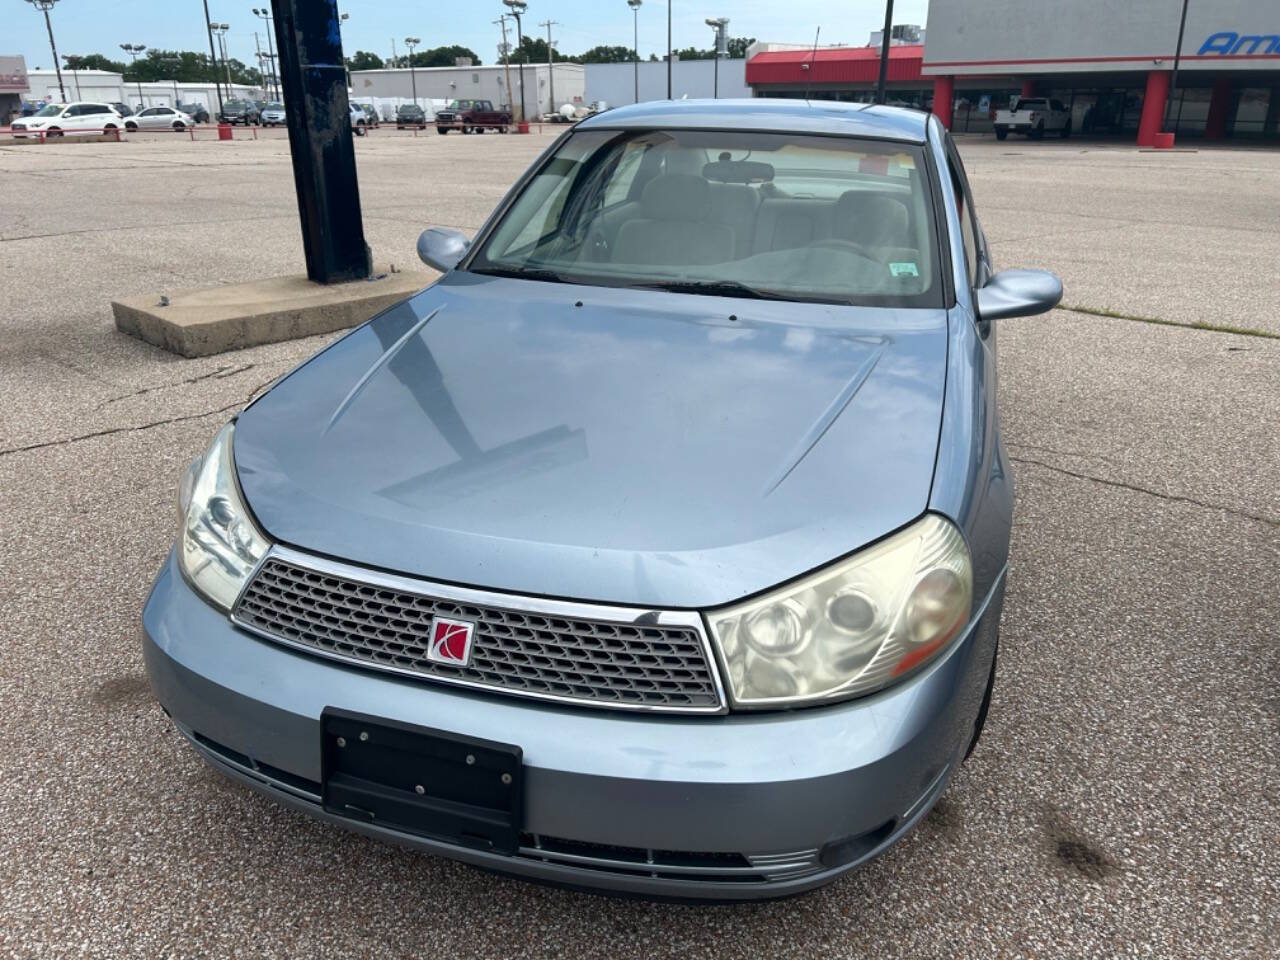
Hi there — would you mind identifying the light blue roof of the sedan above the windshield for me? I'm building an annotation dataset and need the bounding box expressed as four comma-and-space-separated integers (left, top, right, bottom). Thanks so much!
577, 97, 929, 143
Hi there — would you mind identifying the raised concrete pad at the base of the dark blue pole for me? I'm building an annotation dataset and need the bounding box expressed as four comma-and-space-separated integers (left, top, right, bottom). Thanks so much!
111, 270, 434, 357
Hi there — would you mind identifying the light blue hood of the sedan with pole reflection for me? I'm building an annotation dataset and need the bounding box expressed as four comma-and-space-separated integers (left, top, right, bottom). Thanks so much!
234, 273, 947, 608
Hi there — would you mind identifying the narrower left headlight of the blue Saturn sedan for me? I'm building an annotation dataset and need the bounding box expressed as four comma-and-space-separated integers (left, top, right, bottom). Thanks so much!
178, 424, 269, 611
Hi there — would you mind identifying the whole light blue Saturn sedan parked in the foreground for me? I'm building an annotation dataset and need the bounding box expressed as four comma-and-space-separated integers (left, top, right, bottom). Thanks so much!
142, 99, 1062, 900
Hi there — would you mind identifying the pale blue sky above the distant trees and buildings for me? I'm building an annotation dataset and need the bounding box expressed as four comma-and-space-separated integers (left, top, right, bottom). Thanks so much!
10, 0, 928, 69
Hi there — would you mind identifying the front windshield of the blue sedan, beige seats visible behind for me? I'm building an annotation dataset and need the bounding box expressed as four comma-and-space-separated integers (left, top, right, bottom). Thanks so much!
467, 131, 942, 306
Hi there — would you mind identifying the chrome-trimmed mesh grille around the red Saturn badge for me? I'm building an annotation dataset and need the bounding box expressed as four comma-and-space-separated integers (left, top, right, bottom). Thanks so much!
233, 553, 722, 712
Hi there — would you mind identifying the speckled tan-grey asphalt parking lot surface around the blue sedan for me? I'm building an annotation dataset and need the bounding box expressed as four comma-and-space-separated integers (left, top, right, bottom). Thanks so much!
0, 131, 1280, 957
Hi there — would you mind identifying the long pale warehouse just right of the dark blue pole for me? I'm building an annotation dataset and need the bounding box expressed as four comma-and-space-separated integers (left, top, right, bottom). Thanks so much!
351, 63, 585, 119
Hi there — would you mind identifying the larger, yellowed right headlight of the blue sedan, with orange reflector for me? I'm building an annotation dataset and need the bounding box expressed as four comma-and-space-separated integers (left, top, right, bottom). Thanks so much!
707, 515, 973, 708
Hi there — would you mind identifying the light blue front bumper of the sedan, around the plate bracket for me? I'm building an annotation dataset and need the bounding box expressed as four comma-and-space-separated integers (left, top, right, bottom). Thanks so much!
143, 554, 1004, 900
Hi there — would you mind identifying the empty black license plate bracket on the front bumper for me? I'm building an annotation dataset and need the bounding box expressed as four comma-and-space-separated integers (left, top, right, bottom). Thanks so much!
320, 707, 525, 855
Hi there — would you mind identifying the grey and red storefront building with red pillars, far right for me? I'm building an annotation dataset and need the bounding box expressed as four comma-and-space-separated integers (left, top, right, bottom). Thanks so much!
746, 0, 1280, 146
